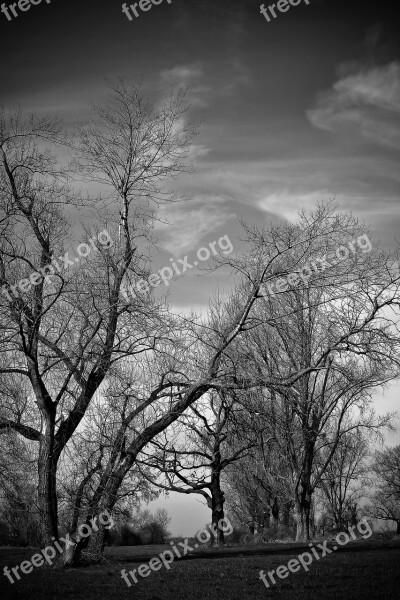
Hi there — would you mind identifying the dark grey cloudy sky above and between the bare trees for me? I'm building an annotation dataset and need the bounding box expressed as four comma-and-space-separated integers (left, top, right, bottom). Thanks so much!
0, 0, 400, 534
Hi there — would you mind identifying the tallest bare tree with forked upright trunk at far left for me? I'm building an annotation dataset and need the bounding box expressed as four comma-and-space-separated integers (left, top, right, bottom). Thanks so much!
0, 83, 193, 544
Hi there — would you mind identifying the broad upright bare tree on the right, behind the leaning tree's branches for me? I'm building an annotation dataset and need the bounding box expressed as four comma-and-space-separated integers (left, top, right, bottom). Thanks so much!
214, 204, 399, 540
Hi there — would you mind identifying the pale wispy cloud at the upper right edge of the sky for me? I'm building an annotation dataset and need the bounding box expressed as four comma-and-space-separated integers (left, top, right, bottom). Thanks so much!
307, 62, 400, 150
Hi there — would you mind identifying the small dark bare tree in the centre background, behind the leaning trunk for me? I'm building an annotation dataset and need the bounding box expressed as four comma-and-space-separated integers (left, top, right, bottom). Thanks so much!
139, 391, 259, 545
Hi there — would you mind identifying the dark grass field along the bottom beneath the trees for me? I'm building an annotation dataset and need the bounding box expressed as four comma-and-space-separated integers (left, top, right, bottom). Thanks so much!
0, 540, 400, 600
